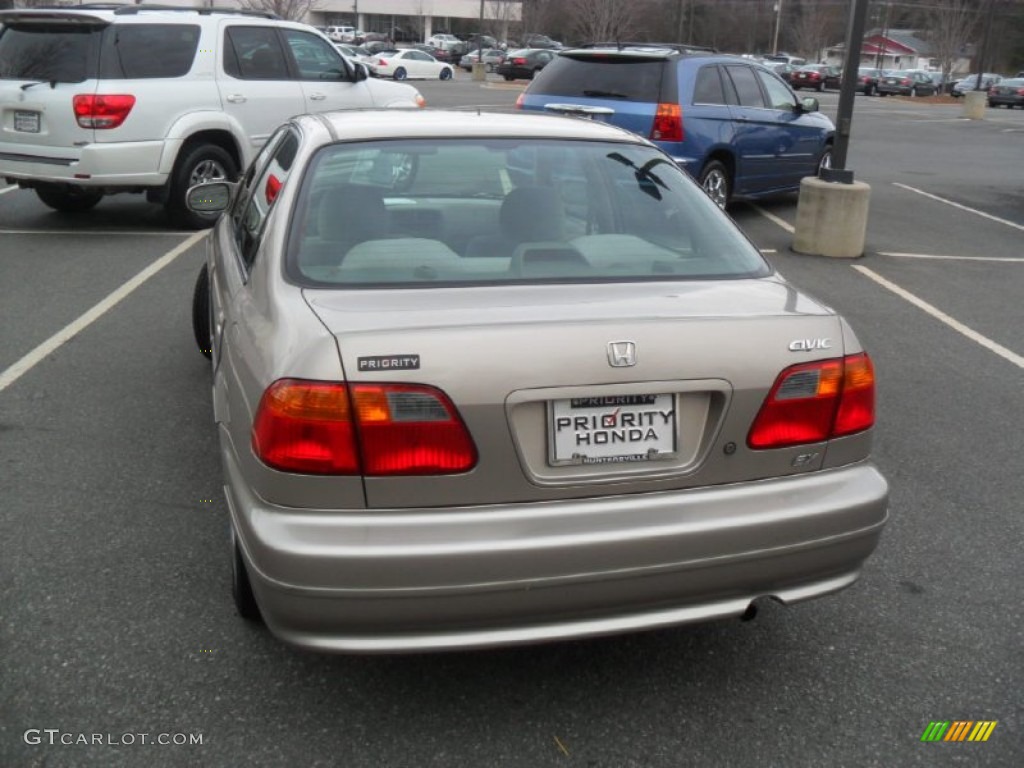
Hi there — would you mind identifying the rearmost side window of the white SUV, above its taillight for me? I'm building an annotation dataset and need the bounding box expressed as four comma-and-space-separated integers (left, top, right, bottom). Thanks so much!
99, 24, 200, 80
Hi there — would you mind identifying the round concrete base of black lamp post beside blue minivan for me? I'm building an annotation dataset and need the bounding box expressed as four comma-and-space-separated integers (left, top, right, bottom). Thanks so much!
793, 176, 871, 259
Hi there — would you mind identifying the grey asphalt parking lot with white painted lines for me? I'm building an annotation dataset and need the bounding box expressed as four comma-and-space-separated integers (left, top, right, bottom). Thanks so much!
0, 76, 1024, 768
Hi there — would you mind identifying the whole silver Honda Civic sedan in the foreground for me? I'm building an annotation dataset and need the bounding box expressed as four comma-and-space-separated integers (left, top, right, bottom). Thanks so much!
189, 110, 888, 652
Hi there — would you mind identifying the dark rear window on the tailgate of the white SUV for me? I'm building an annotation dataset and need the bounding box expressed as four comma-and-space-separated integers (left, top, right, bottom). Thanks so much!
0, 24, 101, 83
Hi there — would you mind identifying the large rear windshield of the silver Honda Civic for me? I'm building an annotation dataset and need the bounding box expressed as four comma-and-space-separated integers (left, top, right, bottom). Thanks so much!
287, 139, 770, 288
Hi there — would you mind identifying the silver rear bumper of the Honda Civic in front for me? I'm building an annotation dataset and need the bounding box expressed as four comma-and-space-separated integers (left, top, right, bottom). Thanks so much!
223, 446, 888, 652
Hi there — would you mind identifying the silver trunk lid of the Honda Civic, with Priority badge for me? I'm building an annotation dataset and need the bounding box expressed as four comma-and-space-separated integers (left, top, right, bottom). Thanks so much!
304, 278, 843, 508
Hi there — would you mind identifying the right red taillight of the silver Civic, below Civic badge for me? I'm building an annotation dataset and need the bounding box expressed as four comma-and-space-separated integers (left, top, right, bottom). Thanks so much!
746, 353, 874, 449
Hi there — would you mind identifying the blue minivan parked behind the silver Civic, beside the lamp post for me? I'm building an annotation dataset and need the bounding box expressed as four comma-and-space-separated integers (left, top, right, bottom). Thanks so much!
516, 44, 836, 208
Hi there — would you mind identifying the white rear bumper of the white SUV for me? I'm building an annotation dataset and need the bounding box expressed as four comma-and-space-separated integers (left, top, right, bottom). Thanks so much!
0, 141, 168, 187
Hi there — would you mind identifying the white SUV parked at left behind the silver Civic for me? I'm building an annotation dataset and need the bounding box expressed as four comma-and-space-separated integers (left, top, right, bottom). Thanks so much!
0, 5, 424, 228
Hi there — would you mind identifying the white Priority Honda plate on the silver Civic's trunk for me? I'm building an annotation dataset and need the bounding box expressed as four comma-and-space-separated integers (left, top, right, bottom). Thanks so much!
548, 394, 676, 466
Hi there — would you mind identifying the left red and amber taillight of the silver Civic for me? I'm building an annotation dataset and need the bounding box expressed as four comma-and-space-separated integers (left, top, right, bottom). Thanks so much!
252, 379, 476, 476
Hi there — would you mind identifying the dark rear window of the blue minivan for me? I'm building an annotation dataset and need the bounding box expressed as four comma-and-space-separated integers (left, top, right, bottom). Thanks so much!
529, 55, 676, 103
